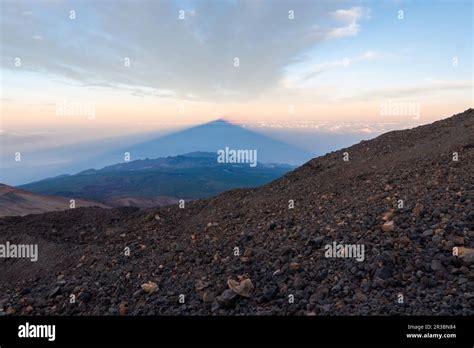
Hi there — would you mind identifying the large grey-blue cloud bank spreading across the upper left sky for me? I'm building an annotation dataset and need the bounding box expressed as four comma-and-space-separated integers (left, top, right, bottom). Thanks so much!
1, 0, 369, 101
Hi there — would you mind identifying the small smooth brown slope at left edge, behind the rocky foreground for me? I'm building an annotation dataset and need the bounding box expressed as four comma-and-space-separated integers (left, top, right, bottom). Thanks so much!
0, 184, 107, 217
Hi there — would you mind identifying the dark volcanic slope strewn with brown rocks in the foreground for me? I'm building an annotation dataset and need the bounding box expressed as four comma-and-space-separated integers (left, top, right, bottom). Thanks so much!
0, 109, 474, 315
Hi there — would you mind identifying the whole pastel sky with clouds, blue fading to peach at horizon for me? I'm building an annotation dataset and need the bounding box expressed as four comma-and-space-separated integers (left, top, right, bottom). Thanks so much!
0, 0, 473, 146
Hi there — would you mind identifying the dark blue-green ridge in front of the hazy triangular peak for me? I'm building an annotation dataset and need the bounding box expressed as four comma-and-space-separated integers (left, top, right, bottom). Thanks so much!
21, 152, 293, 207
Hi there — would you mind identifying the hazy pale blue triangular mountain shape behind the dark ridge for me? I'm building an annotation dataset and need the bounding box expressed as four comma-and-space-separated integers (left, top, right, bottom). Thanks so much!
0, 120, 314, 185
